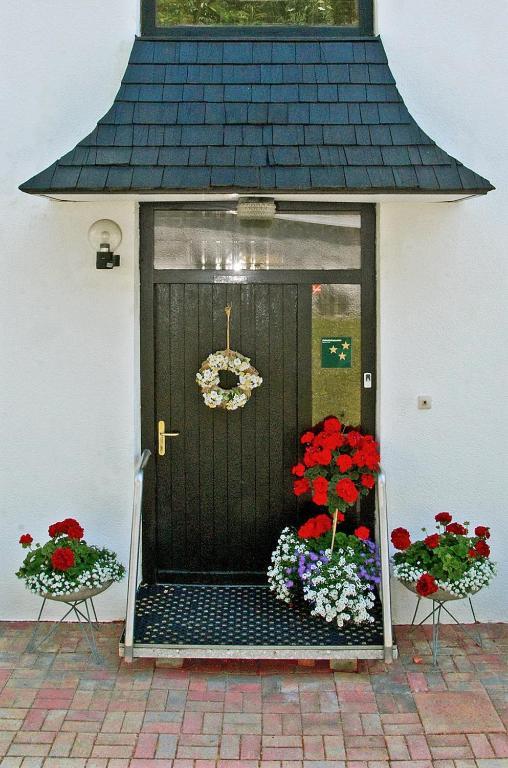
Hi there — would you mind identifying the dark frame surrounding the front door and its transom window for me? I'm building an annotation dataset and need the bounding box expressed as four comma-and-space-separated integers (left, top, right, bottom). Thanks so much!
139, 200, 377, 583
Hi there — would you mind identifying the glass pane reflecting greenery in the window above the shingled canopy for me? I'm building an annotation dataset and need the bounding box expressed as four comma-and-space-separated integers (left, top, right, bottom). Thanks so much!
156, 0, 359, 27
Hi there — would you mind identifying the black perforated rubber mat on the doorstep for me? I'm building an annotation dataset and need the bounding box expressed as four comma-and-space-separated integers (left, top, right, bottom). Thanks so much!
134, 584, 383, 646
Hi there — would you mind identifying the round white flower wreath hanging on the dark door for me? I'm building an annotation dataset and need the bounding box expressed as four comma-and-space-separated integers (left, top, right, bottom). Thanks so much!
196, 349, 263, 411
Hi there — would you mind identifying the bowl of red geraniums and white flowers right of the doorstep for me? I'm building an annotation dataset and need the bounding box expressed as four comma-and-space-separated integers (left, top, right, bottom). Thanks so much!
391, 512, 496, 602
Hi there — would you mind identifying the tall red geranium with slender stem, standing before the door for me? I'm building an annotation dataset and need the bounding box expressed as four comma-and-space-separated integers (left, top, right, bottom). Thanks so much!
291, 416, 379, 549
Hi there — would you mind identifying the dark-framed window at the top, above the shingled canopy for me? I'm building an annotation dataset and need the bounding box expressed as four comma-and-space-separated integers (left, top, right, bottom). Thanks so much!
141, 0, 373, 37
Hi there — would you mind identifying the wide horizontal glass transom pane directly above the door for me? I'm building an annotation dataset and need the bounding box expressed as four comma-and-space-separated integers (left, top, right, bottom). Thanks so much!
154, 209, 361, 271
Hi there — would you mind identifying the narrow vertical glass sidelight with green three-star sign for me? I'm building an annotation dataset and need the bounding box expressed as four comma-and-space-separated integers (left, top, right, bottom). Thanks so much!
312, 284, 362, 424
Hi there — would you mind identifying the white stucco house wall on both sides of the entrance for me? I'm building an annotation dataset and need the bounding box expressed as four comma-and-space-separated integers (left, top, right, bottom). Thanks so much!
0, 0, 508, 621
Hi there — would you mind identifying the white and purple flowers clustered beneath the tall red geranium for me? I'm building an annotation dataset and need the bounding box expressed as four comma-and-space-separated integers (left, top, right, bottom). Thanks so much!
268, 528, 380, 627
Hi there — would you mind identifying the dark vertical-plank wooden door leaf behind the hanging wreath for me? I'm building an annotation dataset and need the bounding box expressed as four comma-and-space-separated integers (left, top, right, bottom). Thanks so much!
154, 283, 310, 581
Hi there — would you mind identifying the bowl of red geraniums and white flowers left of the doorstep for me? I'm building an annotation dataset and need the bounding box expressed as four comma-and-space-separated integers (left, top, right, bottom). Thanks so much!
16, 517, 125, 602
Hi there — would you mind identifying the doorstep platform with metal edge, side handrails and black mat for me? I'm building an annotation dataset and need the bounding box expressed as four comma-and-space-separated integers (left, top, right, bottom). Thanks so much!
119, 450, 396, 662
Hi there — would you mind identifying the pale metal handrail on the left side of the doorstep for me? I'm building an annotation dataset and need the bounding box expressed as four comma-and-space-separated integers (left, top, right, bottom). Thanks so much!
124, 448, 151, 662
